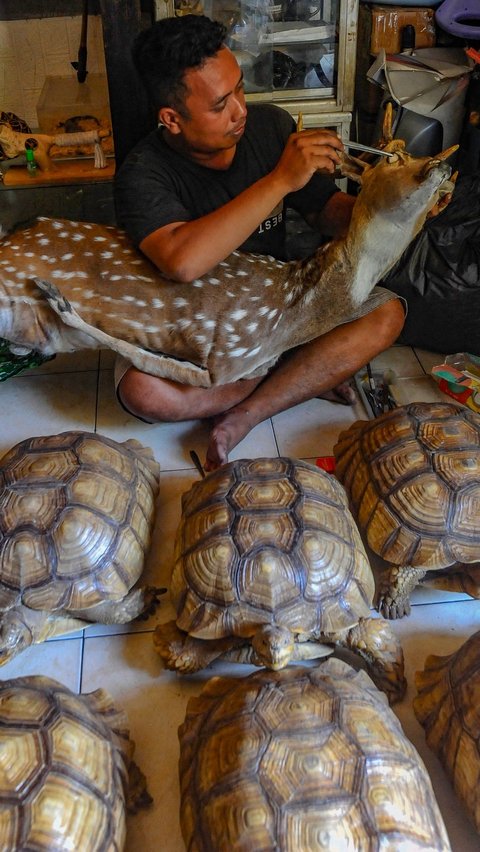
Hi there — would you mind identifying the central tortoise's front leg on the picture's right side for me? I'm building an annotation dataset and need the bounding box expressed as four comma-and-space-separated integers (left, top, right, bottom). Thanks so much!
332, 618, 407, 704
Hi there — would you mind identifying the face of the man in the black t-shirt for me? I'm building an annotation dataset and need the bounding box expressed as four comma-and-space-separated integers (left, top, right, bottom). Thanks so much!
174, 47, 247, 156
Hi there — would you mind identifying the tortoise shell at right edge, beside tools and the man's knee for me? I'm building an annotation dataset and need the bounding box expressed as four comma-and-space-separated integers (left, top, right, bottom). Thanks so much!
334, 403, 480, 570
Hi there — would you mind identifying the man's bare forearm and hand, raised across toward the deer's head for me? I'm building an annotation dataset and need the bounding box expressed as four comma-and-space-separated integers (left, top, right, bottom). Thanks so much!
140, 130, 342, 282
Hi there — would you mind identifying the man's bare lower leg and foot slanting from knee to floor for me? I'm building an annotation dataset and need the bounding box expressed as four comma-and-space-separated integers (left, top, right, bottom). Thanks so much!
205, 300, 405, 470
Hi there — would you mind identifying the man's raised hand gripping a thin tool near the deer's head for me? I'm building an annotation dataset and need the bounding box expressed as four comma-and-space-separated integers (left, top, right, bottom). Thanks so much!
274, 130, 343, 194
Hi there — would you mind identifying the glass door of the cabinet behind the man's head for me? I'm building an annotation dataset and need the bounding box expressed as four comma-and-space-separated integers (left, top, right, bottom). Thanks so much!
175, 0, 340, 100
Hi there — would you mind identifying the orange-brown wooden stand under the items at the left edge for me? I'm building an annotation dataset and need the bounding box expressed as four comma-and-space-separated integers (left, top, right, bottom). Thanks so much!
3, 157, 115, 186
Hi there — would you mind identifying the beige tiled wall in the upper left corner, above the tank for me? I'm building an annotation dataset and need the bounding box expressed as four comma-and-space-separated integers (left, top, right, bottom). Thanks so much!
0, 15, 105, 130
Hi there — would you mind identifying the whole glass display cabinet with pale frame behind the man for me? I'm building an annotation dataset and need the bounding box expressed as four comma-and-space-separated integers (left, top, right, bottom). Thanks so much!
155, 0, 358, 140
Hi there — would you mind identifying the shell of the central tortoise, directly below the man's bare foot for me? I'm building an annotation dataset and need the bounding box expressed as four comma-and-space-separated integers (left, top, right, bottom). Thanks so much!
171, 458, 374, 639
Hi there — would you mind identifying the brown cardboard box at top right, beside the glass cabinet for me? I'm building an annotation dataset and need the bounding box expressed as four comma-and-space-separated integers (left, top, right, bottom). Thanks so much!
370, 6, 436, 56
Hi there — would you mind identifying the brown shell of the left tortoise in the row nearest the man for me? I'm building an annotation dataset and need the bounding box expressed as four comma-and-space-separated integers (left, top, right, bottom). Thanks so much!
0, 432, 159, 611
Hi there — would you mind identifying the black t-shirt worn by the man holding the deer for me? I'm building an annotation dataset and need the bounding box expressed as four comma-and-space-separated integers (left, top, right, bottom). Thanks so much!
115, 104, 337, 258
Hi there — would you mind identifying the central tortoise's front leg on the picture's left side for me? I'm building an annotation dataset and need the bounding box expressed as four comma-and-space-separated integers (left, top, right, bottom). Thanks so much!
153, 621, 244, 674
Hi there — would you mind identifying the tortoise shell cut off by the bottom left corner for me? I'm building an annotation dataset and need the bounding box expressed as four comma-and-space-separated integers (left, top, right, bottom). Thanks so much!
0, 676, 151, 852
